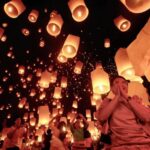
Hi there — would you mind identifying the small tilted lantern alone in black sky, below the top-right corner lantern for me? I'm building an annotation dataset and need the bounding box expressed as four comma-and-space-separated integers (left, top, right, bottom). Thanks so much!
114, 15, 131, 32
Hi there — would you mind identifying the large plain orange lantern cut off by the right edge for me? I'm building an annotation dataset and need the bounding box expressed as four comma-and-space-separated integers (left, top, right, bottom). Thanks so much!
127, 19, 150, 81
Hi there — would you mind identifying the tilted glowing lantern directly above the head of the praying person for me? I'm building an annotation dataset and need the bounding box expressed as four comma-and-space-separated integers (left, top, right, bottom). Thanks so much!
115, 48, 143, 83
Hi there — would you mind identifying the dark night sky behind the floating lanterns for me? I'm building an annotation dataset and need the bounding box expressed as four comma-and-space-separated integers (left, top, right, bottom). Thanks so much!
0, 0, 150, 122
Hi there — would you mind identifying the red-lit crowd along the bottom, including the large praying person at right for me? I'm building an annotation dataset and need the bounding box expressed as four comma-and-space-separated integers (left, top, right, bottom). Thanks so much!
1, 76, 150, 150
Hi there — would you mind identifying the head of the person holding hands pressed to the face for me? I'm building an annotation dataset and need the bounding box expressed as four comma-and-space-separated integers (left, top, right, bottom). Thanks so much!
112, 77, 128, 94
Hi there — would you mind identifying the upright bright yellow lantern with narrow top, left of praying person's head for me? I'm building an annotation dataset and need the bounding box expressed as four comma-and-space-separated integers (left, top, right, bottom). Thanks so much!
91, 64, 110, 94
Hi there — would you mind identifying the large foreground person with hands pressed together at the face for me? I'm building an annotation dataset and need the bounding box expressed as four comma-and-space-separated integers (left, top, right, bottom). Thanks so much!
96, 76, 150, 150
